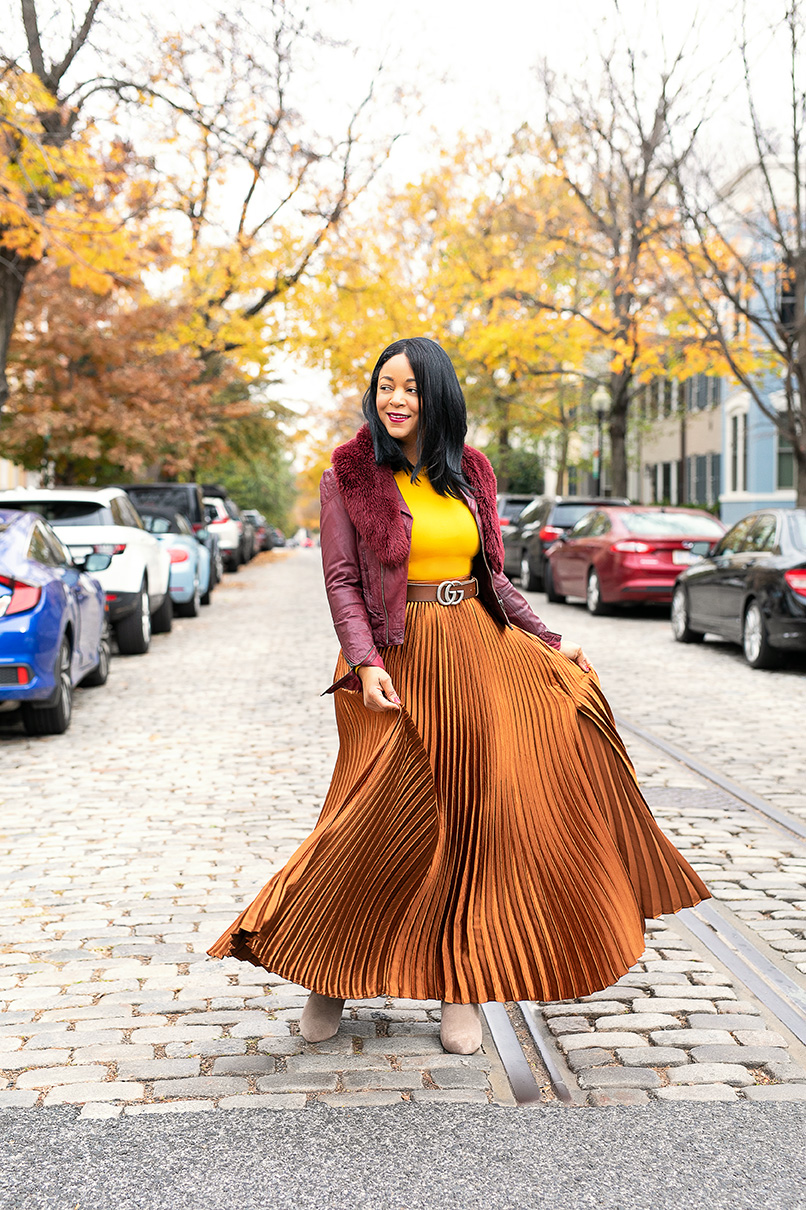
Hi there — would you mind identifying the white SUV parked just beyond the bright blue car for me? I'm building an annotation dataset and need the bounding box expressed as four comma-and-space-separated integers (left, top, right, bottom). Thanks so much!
0, 488, 173, 656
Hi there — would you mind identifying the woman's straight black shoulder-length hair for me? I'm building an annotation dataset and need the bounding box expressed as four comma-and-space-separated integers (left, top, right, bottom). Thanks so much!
362, 336, 472, 496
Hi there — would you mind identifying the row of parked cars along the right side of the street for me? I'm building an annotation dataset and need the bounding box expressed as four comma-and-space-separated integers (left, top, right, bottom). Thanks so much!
499, 496, 806, 668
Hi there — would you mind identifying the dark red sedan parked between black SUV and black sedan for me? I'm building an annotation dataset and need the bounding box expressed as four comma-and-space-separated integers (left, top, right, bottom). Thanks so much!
546, 505, 725, 613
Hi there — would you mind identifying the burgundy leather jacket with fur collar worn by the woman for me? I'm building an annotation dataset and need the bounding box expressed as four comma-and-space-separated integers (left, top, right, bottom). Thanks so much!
319, 425, 560, 692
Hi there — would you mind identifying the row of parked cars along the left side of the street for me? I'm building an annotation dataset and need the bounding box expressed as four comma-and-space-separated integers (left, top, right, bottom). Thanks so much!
0, 483, 285, 734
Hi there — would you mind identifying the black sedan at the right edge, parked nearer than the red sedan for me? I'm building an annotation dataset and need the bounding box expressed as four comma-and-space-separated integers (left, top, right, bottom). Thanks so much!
672, 508, 806, 668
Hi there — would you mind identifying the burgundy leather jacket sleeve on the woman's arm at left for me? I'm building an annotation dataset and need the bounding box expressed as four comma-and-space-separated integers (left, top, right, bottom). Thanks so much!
319, 472, 384, 688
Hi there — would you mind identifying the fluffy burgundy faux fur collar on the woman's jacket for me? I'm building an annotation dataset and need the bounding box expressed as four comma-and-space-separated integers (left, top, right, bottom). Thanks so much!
333, 425, 503, 571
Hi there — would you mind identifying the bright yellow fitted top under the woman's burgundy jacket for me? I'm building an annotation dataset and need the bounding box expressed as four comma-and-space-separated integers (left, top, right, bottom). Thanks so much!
395, 471, 479, 580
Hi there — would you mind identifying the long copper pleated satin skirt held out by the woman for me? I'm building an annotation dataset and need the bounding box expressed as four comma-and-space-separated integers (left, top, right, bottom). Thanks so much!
209, 599, 708, 1003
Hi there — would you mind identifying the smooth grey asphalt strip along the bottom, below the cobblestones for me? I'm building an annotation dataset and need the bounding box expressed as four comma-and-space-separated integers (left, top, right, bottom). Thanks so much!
0, 1105, 806, 1210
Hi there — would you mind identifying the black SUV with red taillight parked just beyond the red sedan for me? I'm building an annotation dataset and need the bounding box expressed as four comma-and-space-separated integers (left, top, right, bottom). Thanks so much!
501, 496, 629, 592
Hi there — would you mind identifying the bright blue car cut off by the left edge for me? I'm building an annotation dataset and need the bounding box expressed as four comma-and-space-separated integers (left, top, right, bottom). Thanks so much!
0, 508, 111, 736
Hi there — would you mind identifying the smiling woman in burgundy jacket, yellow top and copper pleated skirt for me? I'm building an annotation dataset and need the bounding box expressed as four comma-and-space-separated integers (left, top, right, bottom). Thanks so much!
209, 336, 708, 1054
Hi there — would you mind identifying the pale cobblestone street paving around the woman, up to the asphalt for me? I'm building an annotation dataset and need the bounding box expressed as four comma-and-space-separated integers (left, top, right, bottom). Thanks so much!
0, 552, 806, 1118
